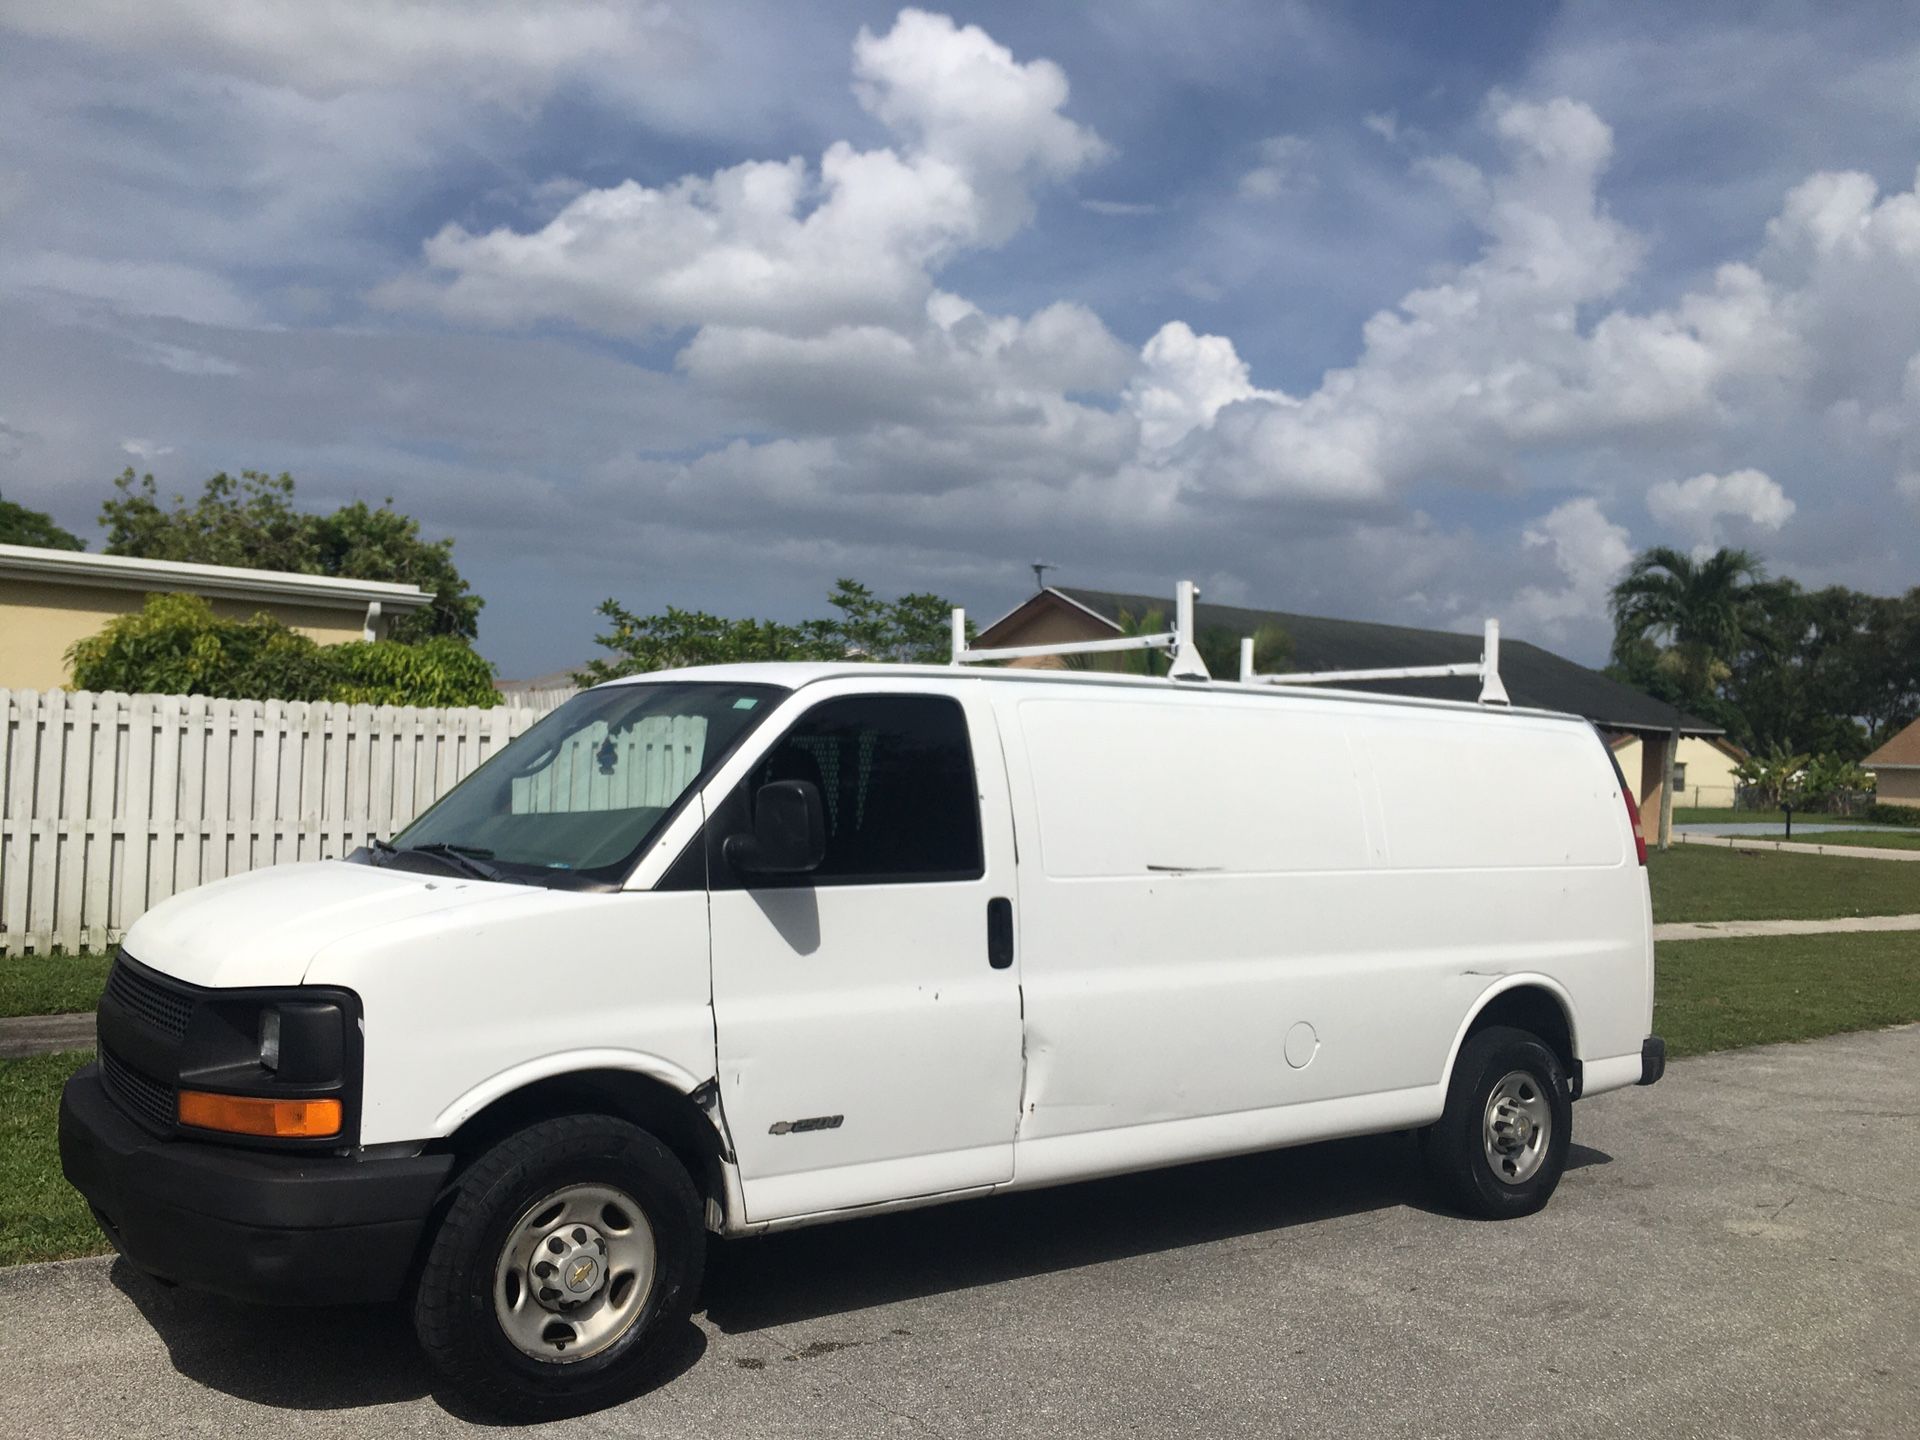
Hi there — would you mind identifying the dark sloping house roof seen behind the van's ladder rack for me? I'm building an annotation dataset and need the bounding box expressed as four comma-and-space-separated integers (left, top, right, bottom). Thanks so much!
981, 586, 1722, 735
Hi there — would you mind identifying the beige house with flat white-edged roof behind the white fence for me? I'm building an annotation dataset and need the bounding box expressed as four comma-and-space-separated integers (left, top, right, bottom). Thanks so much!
0, 545, 434, 689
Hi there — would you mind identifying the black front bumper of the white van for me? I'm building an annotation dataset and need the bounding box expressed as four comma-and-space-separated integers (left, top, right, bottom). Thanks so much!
60, 1064, 453, 1306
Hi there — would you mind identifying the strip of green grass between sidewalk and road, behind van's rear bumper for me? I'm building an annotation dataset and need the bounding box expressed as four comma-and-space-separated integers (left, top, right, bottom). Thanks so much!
1653, 931, 1920, 1056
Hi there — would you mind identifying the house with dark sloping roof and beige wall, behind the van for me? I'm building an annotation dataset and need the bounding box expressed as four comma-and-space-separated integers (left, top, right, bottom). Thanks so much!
973, 586, 1738, 843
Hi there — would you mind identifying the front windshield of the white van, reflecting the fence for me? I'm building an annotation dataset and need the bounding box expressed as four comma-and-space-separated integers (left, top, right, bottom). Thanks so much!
385, 682, 785, 887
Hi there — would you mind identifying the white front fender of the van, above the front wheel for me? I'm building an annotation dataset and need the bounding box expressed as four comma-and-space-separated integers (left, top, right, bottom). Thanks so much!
307, 879, 714, 1144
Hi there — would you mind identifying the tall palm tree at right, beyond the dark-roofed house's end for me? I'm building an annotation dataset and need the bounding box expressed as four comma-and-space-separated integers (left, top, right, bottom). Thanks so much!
1609, 545, 1766, 703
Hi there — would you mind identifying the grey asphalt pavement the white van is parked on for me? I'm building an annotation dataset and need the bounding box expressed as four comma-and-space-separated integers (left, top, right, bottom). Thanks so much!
0, 1027, 1920, 1440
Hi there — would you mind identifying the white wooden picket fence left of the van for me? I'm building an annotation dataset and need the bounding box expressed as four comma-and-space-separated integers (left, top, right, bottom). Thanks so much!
0, 689, 543, 954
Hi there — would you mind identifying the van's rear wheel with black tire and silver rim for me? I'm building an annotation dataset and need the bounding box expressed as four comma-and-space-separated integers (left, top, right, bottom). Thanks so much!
1421, 1025, 1572, 1219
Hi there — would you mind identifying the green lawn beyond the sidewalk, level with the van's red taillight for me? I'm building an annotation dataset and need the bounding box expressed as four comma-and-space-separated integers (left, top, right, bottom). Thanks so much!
1647, 845, 1920, 925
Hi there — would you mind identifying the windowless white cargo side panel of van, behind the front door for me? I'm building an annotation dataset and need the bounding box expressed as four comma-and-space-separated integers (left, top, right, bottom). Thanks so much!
1000, 689, 1647, 1183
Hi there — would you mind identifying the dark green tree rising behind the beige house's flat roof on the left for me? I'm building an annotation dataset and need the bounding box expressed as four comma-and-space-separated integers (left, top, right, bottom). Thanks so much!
100, 468, 484, 641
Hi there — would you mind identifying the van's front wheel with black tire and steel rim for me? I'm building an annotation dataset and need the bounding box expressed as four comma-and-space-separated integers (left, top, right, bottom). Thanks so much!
413, 1116, 707, 1421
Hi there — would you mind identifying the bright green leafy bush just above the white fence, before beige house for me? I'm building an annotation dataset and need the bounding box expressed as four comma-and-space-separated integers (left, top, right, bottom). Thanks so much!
67, 595, 499, 707
